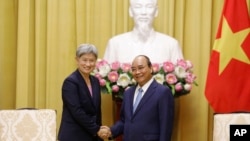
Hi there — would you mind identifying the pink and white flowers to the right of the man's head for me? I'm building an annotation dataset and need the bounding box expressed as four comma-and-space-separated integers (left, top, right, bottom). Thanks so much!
152, 59, 198, 97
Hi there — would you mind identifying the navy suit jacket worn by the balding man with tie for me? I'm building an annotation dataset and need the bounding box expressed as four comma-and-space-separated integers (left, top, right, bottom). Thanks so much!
111, 80, 174, 141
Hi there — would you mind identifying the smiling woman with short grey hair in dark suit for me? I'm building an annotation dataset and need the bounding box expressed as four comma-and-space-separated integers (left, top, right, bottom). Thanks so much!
58, 44, 104, 141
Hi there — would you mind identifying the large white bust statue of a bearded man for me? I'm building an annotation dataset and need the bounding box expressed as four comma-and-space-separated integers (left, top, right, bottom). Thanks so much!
104, 0, 183, 63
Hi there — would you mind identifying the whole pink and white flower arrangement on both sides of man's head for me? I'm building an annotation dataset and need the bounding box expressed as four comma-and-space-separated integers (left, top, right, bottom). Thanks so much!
93, 59, 197, 100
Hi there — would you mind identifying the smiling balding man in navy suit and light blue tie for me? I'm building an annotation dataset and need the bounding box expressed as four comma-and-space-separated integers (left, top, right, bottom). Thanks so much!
102, 55, 174, 141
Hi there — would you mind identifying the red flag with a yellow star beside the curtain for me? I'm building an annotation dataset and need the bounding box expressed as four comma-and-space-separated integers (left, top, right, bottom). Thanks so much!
205, 0, 250, 113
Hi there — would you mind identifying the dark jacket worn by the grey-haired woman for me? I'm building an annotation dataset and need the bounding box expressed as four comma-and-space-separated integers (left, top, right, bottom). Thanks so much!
58, 70, 101, 141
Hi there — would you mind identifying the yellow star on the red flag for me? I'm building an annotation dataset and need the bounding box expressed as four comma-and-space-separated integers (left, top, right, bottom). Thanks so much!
213, 17, 250, 74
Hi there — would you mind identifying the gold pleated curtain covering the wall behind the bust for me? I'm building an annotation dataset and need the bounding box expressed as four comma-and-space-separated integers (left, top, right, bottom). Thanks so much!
0, 0, 246, 141
